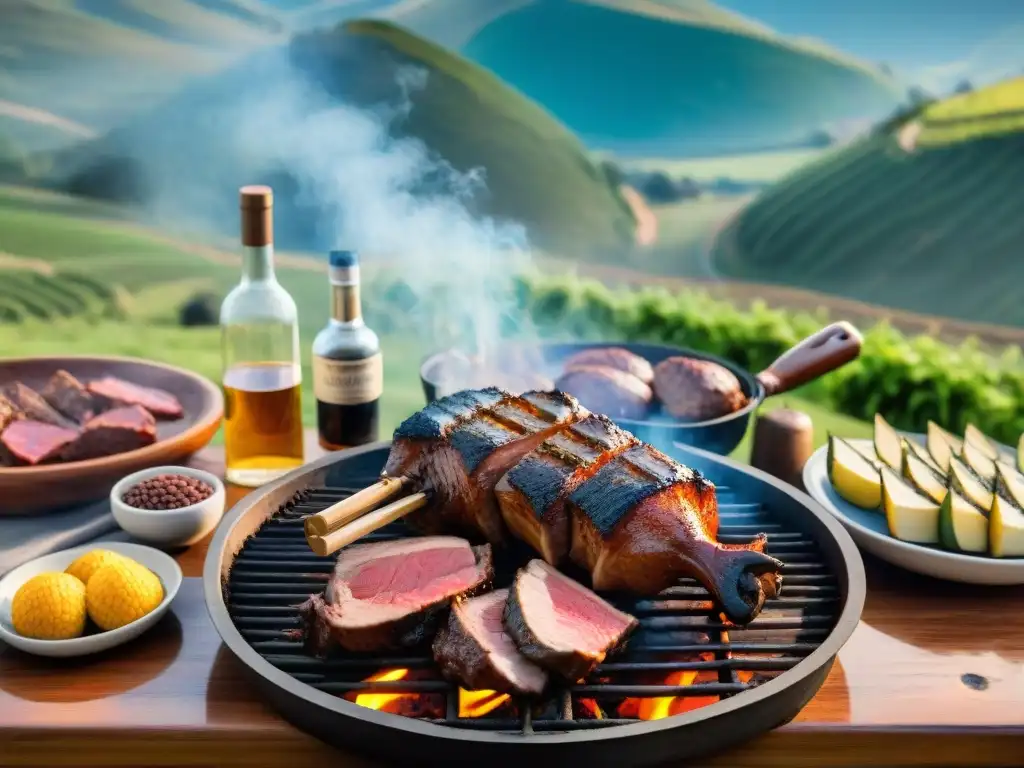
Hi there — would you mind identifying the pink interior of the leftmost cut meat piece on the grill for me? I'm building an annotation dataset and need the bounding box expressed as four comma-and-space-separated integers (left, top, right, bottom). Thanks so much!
348, 547, 478, 605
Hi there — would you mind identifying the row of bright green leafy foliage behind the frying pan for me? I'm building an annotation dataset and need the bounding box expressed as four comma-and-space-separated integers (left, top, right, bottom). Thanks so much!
419, 276, 1024, 445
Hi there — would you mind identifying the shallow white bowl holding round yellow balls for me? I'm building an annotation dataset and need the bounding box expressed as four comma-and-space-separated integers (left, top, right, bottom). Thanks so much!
0, 542, 181, 657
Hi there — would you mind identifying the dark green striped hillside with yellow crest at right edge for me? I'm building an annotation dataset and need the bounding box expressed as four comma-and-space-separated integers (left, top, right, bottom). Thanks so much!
714, 78, 1024, 327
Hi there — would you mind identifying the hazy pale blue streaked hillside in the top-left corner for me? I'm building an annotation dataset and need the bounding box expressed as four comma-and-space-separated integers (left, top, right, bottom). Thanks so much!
0, 0, 286, 128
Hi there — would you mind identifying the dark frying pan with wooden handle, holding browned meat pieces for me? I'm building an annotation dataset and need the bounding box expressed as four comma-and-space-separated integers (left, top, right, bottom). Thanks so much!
420, 322, 863, 456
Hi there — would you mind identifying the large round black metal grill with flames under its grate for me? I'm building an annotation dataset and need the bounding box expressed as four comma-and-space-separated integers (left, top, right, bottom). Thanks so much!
204, 443, 864, 766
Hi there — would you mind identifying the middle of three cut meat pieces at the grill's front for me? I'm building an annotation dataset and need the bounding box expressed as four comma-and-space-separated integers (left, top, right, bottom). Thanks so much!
433, 590, 548, 696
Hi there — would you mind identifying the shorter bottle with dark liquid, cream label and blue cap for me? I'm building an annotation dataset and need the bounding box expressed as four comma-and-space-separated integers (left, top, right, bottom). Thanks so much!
312, 251, 384, 451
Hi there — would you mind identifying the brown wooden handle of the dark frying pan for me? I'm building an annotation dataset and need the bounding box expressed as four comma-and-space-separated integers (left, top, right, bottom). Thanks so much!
758, 321, 864, 397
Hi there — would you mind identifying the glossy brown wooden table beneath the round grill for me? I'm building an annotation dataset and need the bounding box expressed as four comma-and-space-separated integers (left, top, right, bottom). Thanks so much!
0, 434, 1024, 768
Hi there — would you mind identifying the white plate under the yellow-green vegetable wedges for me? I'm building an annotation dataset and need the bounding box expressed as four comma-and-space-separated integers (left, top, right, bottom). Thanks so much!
804, 434, 1024, 586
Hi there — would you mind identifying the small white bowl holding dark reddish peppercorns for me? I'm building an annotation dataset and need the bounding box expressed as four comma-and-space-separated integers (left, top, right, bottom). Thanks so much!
111, 467, 226, 548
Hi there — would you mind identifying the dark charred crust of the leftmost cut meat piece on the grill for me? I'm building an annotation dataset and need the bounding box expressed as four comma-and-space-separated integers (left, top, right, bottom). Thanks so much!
299, 544, 495, 656
